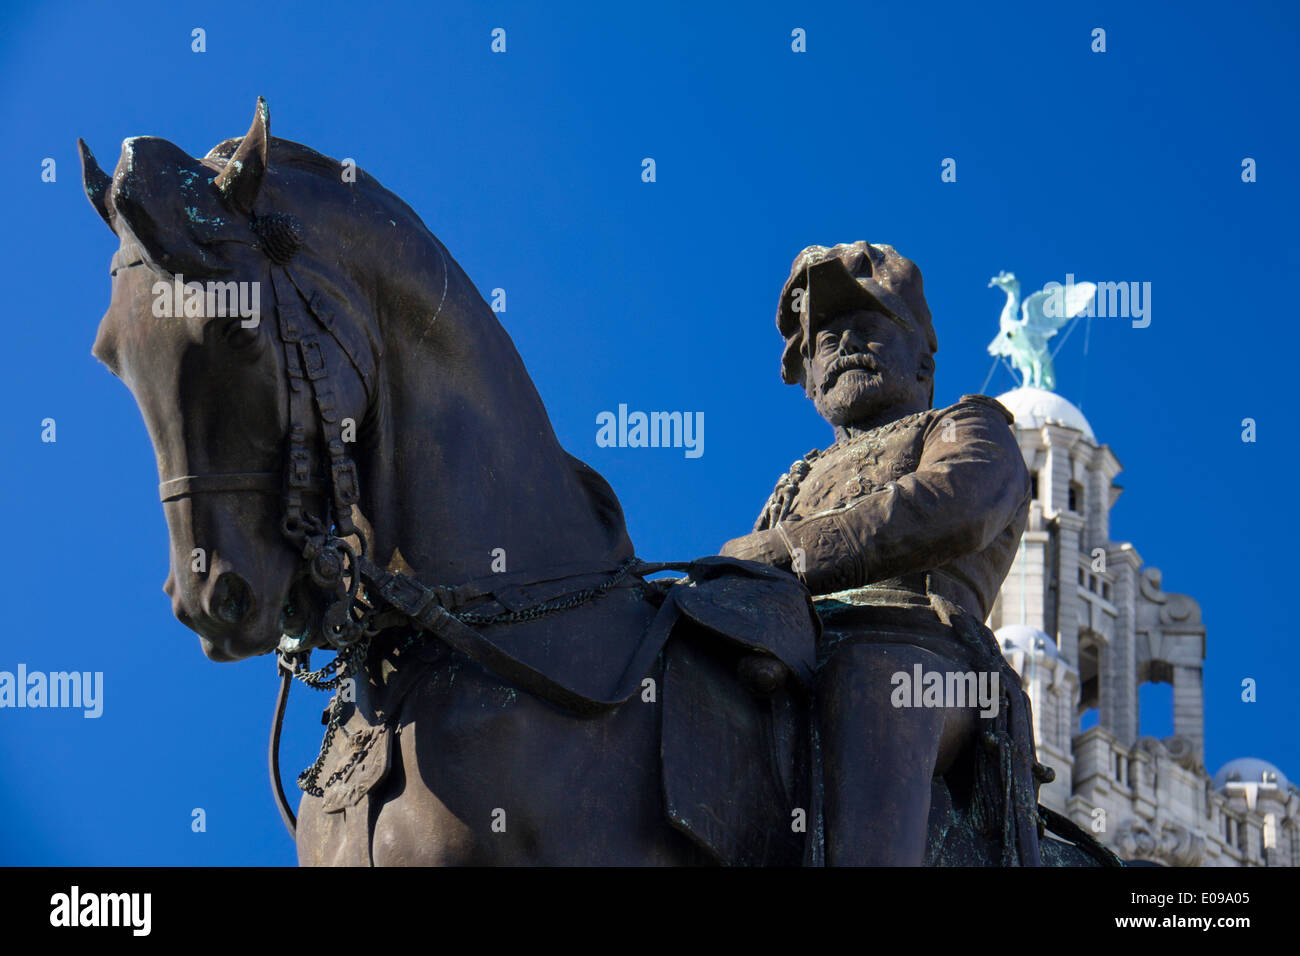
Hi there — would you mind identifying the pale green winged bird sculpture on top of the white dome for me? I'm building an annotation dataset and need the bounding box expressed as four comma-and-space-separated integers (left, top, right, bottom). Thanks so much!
988, 272, 1097, 392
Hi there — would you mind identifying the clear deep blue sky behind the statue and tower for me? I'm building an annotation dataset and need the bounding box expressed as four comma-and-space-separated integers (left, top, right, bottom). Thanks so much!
0, 0, 1300, 865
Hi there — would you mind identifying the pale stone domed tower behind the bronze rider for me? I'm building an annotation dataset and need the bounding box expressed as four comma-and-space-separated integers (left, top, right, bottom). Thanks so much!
989, 280, 1300, 866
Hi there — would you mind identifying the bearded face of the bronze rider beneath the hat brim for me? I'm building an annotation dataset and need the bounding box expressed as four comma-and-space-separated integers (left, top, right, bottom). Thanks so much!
807, 311, 928, 425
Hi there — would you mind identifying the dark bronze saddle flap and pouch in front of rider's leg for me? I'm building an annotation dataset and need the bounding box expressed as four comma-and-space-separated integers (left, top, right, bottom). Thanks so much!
659, 558, 822, 866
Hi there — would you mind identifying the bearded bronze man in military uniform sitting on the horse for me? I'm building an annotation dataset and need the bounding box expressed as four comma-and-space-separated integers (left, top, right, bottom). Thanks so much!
723, 242, 1037, 866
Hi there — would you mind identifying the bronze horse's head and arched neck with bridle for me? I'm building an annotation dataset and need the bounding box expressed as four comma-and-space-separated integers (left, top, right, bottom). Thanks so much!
81, 99, 632, 661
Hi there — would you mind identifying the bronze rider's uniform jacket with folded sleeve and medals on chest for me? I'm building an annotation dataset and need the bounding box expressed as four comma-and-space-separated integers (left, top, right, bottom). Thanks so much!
754, 395, 1030, 620
